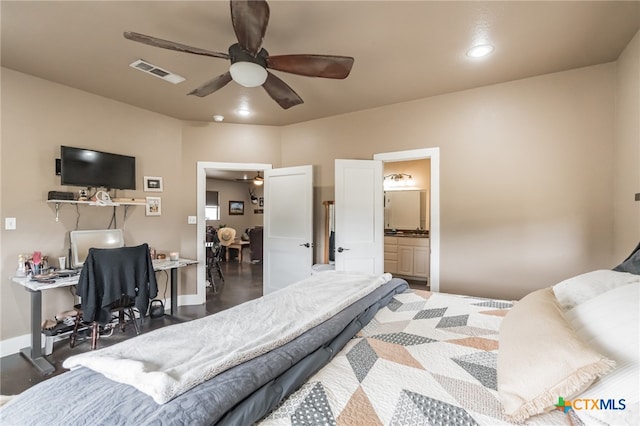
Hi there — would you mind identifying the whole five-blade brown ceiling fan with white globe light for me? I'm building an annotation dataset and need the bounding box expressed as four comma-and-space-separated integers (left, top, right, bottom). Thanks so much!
124, 0, 353, 109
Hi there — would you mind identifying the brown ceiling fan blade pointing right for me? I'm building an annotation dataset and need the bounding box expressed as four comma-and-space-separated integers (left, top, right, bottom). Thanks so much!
266, 55, 353, 79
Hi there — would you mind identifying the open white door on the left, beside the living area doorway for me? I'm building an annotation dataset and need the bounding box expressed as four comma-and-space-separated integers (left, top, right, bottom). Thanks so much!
263, 166, 313, 294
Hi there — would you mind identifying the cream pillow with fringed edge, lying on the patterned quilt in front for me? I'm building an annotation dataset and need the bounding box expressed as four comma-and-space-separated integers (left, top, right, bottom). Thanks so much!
497, 288, 615, 423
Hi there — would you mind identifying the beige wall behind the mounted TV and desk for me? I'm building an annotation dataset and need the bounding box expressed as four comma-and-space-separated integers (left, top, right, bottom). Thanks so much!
0, 68, 280, 341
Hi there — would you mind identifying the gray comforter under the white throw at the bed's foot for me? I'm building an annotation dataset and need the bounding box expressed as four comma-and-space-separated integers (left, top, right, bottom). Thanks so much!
0, 278, 407, 426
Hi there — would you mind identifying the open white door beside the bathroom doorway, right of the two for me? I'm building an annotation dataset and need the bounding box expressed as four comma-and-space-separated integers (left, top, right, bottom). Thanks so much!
335, 160, 384, 274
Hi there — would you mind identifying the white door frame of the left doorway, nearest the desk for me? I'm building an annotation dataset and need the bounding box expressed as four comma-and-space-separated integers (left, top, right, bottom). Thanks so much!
195, 161, 273, 304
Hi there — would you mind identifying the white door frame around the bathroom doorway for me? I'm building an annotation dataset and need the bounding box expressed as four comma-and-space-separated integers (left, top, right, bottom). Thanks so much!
373, 147, 440, 292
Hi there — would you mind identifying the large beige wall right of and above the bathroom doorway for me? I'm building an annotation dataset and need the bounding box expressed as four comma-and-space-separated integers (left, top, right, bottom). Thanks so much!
282, 64, 616, 298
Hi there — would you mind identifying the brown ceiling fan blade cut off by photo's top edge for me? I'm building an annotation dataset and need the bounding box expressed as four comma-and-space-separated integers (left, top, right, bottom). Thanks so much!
231, 0, 269, 57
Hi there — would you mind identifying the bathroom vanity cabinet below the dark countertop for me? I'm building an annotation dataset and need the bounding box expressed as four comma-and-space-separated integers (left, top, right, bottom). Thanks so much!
384, 237, 430, 278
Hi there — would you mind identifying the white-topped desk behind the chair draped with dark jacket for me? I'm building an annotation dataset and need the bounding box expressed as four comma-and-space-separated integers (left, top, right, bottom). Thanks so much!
12, 259, 198, 374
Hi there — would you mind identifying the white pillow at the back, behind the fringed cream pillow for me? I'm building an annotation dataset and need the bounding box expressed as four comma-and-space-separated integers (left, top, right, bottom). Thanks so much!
553, 269, 640, 310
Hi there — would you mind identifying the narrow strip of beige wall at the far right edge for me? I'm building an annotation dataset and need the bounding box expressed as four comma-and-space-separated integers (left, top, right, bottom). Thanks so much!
613, 32, 640, 260
